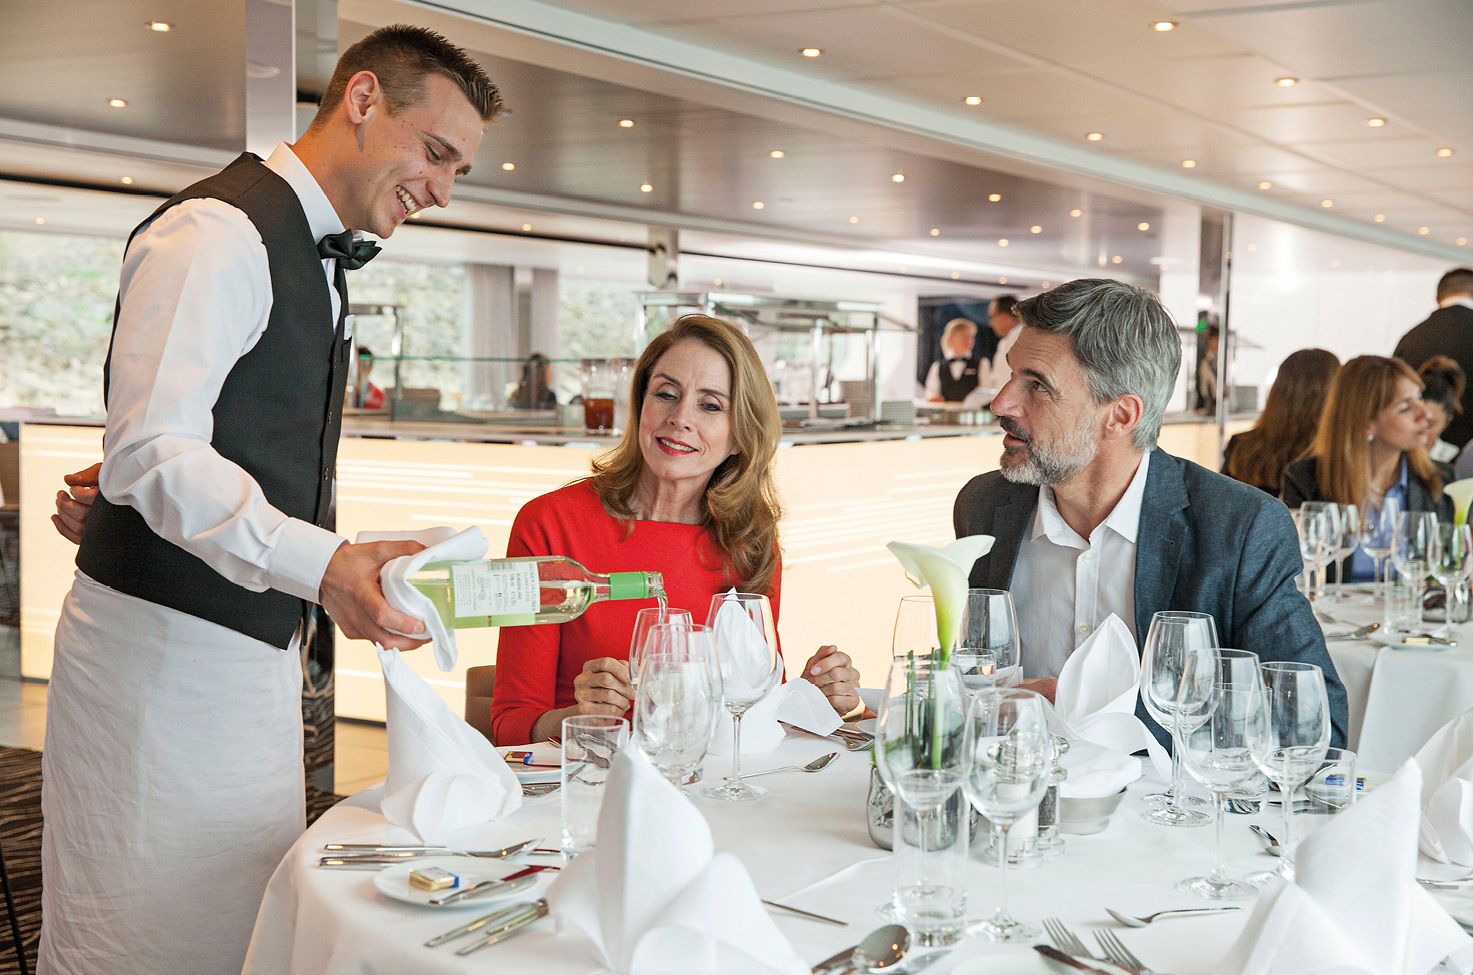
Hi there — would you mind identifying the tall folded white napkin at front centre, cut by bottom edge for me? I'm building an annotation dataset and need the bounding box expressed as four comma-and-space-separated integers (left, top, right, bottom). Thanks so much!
548, 748, 809, 975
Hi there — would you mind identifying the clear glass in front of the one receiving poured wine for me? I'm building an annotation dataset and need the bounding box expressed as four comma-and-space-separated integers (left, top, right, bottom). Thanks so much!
633, 624, 722, 788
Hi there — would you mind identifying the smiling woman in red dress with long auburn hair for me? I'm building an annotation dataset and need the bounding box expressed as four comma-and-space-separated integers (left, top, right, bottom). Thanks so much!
491, 315, 860, 745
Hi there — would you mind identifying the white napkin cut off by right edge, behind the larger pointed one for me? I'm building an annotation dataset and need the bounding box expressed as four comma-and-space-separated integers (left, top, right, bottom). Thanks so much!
1416, 711, 1473, 879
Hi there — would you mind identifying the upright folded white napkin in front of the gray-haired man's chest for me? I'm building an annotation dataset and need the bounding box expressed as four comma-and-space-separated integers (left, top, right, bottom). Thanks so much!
1053, 613, 1171, 798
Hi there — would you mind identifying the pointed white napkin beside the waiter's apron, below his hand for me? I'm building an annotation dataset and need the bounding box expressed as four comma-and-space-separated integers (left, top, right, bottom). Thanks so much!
379, 647, 521, 842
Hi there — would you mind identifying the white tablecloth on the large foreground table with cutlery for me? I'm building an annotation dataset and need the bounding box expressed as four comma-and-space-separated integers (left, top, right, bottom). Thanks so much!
246, 735, 1302, 975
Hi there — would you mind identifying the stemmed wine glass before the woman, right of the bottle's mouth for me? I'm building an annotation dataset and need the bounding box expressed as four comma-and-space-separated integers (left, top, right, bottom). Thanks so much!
701, 592, 782, 803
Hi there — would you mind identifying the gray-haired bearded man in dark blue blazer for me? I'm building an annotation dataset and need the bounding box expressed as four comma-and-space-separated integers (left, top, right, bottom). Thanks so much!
953, 278, 1348, 745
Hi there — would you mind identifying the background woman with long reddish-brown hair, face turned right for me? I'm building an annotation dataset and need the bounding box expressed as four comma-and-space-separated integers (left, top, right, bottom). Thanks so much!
1279, 355, 1452, 582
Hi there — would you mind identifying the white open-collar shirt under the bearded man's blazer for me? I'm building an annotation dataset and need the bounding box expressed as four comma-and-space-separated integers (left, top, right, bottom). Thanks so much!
1012, 450, 1150, 677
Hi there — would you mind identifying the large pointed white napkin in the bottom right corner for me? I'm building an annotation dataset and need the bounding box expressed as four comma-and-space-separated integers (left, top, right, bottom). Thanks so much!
1217, 760, 1473, 975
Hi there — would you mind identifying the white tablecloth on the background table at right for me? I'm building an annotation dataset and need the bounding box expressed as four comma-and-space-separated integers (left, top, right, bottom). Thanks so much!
1315, 586, 1473, 772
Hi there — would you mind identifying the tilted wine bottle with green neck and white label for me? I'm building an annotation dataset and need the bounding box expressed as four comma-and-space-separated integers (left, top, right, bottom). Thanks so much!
409, 555, 664, 629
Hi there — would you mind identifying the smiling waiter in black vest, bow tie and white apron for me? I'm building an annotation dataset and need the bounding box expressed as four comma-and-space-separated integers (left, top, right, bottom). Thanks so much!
38, 27, 501, 975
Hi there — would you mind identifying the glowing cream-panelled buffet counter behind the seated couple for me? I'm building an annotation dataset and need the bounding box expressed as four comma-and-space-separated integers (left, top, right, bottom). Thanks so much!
21, 420, 1246, 720
